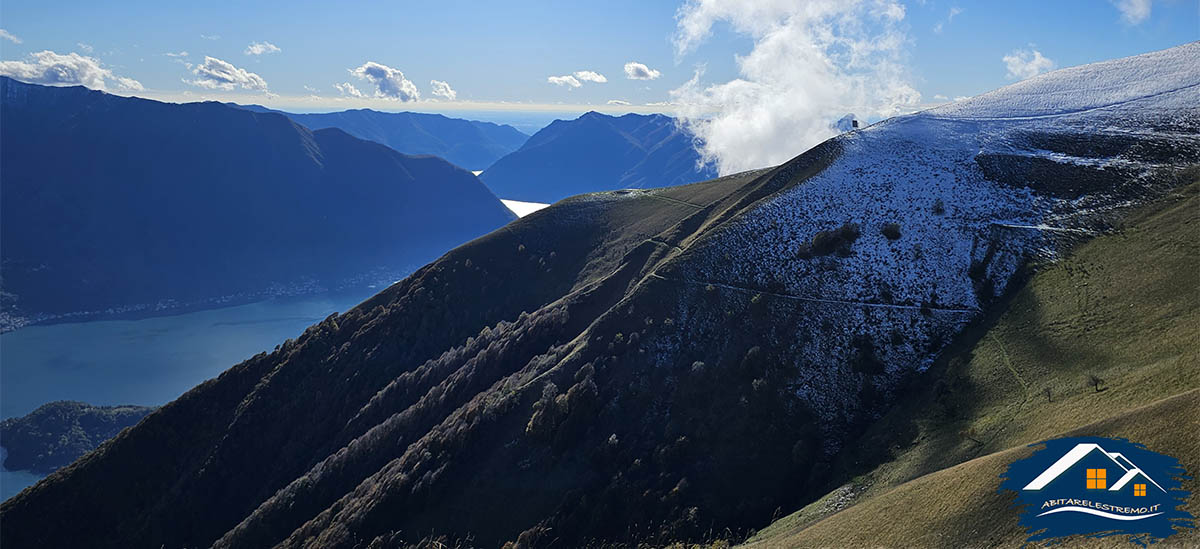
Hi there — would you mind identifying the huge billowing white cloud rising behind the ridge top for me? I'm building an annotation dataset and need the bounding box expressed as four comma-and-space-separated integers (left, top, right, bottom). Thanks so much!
671, 0, 920, 174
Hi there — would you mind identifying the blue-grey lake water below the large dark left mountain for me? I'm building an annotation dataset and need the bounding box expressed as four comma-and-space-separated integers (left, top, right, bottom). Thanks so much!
0, 289, 377, 500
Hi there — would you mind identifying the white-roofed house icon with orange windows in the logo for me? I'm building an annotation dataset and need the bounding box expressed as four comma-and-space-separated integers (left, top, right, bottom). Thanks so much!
1022, 442, 1166, 497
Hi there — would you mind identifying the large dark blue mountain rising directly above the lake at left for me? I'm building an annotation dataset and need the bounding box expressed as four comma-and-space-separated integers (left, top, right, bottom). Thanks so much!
0, 78, 515, 327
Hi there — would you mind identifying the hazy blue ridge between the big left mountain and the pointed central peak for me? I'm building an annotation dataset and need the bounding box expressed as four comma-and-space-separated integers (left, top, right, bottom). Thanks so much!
238, 105, 529, 171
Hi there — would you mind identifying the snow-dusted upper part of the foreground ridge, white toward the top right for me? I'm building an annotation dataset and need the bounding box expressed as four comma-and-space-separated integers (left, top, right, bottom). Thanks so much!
659, 43, 1200, 451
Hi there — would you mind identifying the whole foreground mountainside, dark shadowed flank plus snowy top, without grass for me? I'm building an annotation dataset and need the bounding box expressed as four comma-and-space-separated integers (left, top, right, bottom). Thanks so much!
0, 43, 1200, 548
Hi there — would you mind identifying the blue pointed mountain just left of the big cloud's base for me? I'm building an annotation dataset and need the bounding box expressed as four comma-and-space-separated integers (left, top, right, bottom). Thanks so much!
480, 111, 716, 203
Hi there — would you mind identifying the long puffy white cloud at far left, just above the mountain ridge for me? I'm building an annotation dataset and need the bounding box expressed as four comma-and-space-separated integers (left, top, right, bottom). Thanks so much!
0, 50, 143, 91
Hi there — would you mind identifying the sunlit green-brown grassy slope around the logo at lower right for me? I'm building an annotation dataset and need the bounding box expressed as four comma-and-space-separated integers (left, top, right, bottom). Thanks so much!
748, 178, 1200, 547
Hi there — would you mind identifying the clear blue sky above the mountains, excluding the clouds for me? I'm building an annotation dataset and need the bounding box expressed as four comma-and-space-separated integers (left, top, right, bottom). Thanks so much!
0, 0, 1200, 118
